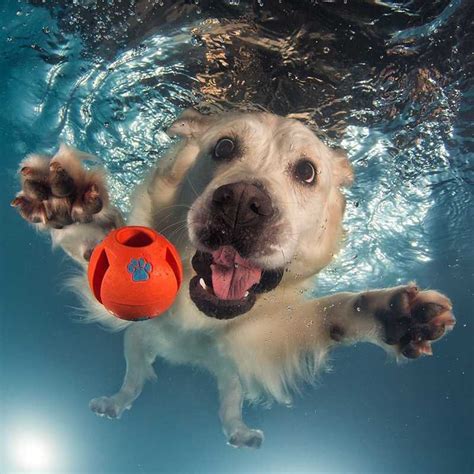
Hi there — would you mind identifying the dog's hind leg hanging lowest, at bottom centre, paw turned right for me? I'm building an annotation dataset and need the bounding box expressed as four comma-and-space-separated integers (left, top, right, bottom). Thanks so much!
217, 373, 263, 448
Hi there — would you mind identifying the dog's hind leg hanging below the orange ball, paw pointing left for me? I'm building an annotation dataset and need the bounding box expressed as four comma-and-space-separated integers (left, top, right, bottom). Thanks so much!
89, 323, 156, 419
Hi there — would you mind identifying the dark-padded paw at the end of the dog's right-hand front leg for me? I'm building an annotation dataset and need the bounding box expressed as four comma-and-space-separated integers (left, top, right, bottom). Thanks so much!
375, 285, 456, 359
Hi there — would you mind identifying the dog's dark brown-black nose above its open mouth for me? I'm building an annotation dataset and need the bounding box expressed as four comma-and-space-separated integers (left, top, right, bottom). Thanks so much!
212, 183, 274, 228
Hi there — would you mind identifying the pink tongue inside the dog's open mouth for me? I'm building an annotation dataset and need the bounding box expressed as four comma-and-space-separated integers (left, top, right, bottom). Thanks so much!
211, 246, 262, 300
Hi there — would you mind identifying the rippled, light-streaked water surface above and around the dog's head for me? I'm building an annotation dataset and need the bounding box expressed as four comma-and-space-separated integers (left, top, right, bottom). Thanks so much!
2, 0, 474, 292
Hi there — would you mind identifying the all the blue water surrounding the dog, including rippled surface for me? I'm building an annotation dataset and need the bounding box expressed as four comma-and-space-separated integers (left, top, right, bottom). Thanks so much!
0, 0, 474, 473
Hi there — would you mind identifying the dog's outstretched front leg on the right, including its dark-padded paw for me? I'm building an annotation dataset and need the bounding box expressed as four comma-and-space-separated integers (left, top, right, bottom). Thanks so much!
311, 284, 455, 358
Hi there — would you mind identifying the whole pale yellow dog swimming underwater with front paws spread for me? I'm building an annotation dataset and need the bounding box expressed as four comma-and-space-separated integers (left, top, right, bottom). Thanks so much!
12, 110, 455, 447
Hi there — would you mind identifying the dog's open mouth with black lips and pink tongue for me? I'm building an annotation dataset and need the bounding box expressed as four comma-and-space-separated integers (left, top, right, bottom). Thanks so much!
189, 245, 283, 319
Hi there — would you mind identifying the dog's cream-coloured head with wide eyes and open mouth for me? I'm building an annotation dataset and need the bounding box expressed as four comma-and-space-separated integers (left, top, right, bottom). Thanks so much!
170, 111, 352, 319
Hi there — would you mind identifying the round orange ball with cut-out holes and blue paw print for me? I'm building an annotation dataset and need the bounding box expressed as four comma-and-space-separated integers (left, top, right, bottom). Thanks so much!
88, 226, 183, 321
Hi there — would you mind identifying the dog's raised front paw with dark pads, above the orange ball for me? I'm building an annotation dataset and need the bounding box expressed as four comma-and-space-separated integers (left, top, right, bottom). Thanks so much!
11, 145, 123, 265
